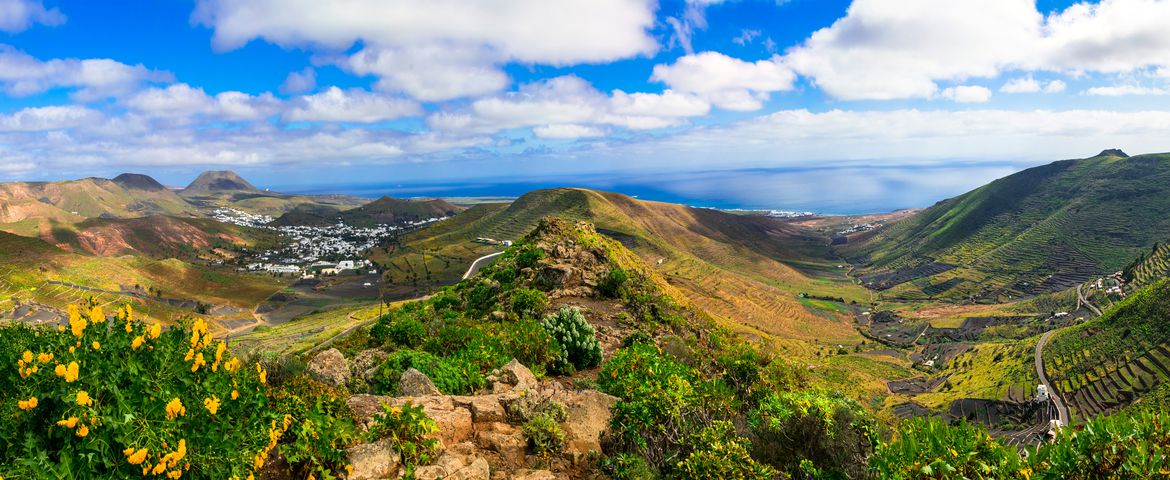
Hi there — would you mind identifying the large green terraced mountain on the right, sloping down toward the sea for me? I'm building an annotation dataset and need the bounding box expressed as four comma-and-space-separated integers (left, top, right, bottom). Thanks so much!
838, 150, 1170, 302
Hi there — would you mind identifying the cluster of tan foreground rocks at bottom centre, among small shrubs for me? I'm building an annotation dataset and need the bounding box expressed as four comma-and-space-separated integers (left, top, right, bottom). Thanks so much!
347, 361, 618, 480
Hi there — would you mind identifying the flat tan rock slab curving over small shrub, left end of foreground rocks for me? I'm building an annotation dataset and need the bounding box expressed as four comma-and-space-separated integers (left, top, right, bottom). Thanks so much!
346, 395, 474, 445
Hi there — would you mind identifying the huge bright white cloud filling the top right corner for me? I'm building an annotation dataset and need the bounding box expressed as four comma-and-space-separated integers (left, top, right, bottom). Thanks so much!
784, 0, 1170, 100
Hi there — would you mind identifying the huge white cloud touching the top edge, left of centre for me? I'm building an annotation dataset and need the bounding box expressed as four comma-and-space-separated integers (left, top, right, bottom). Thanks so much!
193, 0, 658, 101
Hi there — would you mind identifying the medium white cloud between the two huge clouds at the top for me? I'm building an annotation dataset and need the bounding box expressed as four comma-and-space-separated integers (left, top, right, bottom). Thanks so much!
651, 52, 796, 110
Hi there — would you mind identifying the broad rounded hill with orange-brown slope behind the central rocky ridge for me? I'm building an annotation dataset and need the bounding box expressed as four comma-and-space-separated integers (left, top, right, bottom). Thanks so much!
372, 188, 865, 342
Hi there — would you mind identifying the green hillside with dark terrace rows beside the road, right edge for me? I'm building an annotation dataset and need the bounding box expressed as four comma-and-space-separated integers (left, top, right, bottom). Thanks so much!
1044, 280, 1170, 419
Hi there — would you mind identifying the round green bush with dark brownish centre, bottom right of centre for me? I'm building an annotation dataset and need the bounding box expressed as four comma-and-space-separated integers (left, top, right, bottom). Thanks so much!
748, 390, 878, 478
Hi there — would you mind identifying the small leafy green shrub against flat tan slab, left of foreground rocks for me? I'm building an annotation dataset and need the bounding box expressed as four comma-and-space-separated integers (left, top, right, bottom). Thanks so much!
366, 402, 439, 478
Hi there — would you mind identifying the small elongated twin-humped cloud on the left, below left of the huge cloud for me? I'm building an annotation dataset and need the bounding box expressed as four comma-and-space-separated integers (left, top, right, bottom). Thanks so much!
125, 83, 281, 122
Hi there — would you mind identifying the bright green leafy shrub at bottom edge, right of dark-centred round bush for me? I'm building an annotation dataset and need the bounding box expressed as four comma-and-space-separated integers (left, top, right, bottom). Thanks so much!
869, 418, 1031, 480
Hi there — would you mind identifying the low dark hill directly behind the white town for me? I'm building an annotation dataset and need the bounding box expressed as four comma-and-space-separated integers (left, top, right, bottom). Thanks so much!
276, 197, 463, 226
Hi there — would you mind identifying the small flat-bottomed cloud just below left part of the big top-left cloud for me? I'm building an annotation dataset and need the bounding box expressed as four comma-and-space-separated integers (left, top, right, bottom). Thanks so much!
284, 87, 422, 123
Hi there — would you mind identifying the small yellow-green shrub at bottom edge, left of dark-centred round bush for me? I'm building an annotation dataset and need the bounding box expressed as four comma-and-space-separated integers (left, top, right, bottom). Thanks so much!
677, 420, 777, 480
